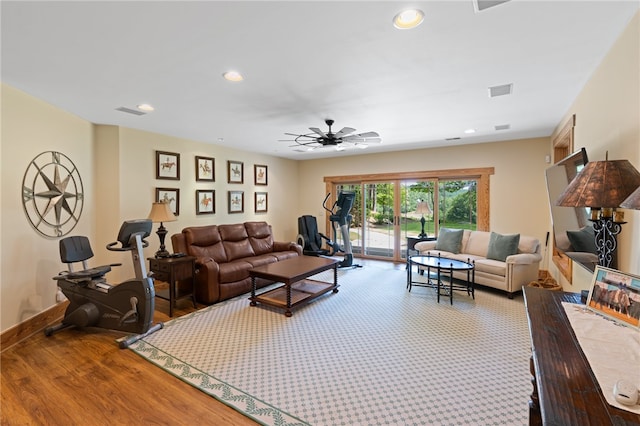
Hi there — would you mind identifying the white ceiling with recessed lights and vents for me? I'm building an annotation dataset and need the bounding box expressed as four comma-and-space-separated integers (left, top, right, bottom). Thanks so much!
1, 0, 640, 159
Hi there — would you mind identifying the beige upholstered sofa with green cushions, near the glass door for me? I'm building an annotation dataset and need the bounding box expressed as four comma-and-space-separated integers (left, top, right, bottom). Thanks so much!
415, 230, 542, 299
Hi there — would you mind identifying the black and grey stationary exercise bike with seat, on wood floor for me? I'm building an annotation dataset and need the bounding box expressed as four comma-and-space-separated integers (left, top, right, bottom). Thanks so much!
44, 219, 163, 349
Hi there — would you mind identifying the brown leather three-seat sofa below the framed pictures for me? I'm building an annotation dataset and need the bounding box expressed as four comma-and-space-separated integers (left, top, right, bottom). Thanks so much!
171, 222, 302, 304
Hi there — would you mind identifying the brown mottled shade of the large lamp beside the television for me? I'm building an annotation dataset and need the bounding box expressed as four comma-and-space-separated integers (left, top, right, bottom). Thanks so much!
556, 160, 640, 208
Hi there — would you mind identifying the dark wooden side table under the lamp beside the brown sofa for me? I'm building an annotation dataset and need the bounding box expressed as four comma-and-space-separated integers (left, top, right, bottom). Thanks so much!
148, 256, 197, 317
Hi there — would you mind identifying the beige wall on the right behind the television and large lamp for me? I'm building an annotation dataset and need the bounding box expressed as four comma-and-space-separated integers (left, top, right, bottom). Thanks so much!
554, 12, 640, 291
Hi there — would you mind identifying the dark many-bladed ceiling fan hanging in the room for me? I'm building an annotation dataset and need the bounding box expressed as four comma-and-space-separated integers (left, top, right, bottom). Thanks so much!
281, 119, 382, 152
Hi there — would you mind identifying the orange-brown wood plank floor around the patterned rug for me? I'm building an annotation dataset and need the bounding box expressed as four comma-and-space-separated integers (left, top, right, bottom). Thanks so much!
0, 259, 404, 425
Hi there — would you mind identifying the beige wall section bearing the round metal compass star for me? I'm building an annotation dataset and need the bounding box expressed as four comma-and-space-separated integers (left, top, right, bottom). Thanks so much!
0, 85, 95, 331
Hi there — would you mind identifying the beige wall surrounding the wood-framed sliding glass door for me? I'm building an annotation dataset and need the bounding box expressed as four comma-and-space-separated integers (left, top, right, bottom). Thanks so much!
298, 138, 549, 241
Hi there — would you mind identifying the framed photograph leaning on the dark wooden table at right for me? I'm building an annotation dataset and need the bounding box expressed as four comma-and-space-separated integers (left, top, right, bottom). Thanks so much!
587, 265, 640, 328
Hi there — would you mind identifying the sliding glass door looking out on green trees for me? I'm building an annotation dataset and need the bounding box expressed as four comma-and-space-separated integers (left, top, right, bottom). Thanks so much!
328, 170, 488, 261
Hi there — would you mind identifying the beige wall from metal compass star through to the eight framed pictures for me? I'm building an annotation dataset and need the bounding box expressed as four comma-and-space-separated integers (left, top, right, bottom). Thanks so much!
0, 84, 298, 331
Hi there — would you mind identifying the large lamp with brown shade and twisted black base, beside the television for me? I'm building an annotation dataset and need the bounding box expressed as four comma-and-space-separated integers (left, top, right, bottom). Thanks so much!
556, 155, 640, 267
